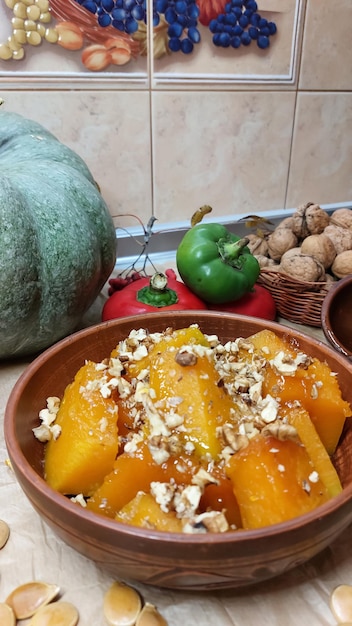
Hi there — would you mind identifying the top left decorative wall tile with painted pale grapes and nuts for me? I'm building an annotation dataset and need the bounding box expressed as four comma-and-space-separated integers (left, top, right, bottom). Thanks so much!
0, 0, 148, 83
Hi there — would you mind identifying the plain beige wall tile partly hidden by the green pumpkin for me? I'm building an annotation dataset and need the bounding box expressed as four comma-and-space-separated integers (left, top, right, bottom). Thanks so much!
2, 91, 152, 224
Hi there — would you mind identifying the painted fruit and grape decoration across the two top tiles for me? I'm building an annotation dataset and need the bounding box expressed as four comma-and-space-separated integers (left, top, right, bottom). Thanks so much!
0, 0, 303, 81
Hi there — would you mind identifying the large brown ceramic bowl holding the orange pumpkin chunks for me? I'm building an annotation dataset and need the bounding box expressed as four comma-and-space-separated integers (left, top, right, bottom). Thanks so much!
5, 311, 352, 590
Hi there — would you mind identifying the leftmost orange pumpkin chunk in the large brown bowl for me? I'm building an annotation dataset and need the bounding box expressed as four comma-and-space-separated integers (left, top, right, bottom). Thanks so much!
44, 362, 118, 496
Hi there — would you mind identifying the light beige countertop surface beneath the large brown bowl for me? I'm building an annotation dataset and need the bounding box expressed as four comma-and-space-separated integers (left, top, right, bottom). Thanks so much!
0, 296, 352, 626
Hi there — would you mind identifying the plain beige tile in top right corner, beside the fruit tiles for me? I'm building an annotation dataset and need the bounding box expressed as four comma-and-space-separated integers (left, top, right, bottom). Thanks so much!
299, 0, 352, 90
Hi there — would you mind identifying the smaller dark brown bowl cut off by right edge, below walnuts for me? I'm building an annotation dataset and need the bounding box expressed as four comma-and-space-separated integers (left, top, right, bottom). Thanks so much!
321, 274, 352, 359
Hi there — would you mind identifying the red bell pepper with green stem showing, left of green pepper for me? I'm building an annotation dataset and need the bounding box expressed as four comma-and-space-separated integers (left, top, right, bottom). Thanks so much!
102, 269, 207, 322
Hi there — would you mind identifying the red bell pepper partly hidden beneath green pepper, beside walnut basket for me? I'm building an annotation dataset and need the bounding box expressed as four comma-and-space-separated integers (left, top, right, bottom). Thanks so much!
208, 283, 276, 321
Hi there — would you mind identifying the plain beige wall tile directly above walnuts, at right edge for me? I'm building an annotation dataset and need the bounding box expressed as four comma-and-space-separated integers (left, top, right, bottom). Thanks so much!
287, 93, 352, 207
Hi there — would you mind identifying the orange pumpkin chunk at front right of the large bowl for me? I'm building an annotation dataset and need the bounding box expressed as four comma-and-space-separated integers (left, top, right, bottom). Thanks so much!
226, 435, 329, 528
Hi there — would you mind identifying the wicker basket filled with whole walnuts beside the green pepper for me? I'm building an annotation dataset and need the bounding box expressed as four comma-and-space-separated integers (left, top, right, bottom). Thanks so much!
248, 202, 352, 327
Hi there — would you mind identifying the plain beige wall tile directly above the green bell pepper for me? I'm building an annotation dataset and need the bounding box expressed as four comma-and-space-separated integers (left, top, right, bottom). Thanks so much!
152, 92, 295, 222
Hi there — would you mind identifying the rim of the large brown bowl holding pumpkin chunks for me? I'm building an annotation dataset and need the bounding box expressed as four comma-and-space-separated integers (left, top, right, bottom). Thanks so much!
4, 310, 352, 545
